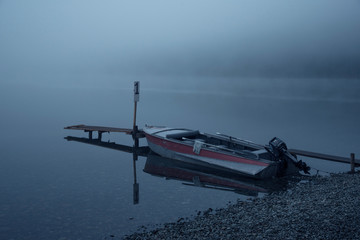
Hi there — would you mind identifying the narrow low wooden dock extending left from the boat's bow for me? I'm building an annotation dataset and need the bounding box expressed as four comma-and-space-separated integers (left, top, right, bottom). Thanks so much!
64, 124, 145, 140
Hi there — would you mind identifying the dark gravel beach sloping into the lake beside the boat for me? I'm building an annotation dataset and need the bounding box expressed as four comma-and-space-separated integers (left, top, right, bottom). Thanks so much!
125, 173, 360, 239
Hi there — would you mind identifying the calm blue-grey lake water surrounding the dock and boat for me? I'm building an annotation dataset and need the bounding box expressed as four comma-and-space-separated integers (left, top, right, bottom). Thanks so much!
0, 76, 360, 239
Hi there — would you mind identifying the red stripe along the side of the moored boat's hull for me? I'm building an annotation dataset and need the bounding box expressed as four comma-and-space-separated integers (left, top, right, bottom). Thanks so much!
145, 134, 269, 166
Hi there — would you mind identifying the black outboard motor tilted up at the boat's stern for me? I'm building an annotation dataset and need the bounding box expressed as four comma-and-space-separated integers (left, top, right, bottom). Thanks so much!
266, 137, 310, 174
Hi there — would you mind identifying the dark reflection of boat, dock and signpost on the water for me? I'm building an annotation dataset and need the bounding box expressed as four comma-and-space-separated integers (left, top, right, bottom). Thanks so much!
65, 136, 296, 204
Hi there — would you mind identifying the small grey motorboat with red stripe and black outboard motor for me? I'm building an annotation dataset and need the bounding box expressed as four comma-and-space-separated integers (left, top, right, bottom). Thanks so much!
143, 125, 310, 179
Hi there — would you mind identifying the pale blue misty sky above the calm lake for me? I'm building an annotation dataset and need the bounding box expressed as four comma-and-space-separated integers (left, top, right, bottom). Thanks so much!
0, 0, 360, 79
